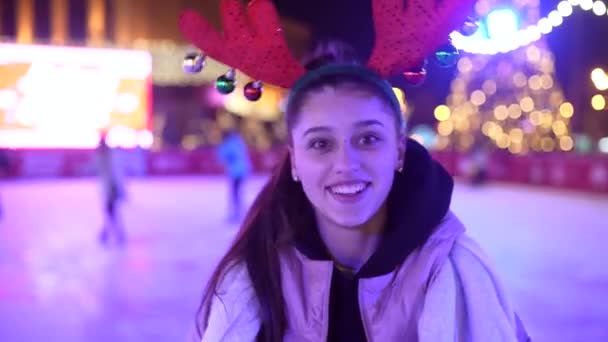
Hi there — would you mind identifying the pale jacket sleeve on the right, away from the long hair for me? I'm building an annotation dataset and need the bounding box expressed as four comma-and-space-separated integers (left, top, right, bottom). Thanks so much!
418, 235, 519, 342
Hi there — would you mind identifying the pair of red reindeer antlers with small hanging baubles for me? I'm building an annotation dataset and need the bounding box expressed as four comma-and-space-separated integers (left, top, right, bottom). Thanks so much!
179, 0, 475, 101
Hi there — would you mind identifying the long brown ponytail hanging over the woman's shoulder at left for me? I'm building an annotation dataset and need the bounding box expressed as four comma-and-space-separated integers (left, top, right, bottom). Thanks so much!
197, 150, 313, 341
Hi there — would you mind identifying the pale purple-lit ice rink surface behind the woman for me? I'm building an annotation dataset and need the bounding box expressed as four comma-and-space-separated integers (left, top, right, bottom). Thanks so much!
0, 177, 608, 342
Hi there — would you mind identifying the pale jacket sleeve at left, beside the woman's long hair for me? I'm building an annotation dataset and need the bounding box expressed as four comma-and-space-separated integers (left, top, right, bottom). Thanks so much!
202, 265, 261, 342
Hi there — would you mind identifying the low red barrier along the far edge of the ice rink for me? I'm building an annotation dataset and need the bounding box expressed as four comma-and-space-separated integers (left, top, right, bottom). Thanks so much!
0, 148, 608, 193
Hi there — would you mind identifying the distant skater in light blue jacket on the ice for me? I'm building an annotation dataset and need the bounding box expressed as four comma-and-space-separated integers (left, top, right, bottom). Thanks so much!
218, 129, 251, 221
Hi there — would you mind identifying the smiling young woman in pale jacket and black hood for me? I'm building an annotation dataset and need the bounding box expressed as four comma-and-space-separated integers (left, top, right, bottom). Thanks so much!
182, 0, 527, 342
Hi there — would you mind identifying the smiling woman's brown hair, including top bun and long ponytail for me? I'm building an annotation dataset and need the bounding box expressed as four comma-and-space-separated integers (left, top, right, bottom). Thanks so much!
197, 43, 401, 342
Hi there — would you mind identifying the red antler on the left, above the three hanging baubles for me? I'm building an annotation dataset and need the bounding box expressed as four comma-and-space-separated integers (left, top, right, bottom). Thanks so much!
179, 0, 305, 88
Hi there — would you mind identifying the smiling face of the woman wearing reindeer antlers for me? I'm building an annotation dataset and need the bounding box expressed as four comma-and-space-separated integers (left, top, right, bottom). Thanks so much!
290, 87, 405, 228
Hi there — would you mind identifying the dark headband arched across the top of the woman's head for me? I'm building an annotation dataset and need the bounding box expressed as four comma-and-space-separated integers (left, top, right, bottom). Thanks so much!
287, 64, 401, 117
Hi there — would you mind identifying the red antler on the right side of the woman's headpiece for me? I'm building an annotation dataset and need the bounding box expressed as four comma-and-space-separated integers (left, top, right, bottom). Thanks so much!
368, 0, 475, 78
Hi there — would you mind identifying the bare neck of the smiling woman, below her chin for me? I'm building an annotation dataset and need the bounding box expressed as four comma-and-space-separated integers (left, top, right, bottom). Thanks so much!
317, 203, 387, 272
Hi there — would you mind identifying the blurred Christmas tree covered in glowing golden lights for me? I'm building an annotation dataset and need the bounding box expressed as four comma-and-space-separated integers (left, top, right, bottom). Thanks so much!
435, 0, 574, 154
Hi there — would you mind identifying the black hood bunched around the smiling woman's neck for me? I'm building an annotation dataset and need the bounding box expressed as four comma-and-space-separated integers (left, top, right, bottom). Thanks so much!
296, 139, 454, 278
